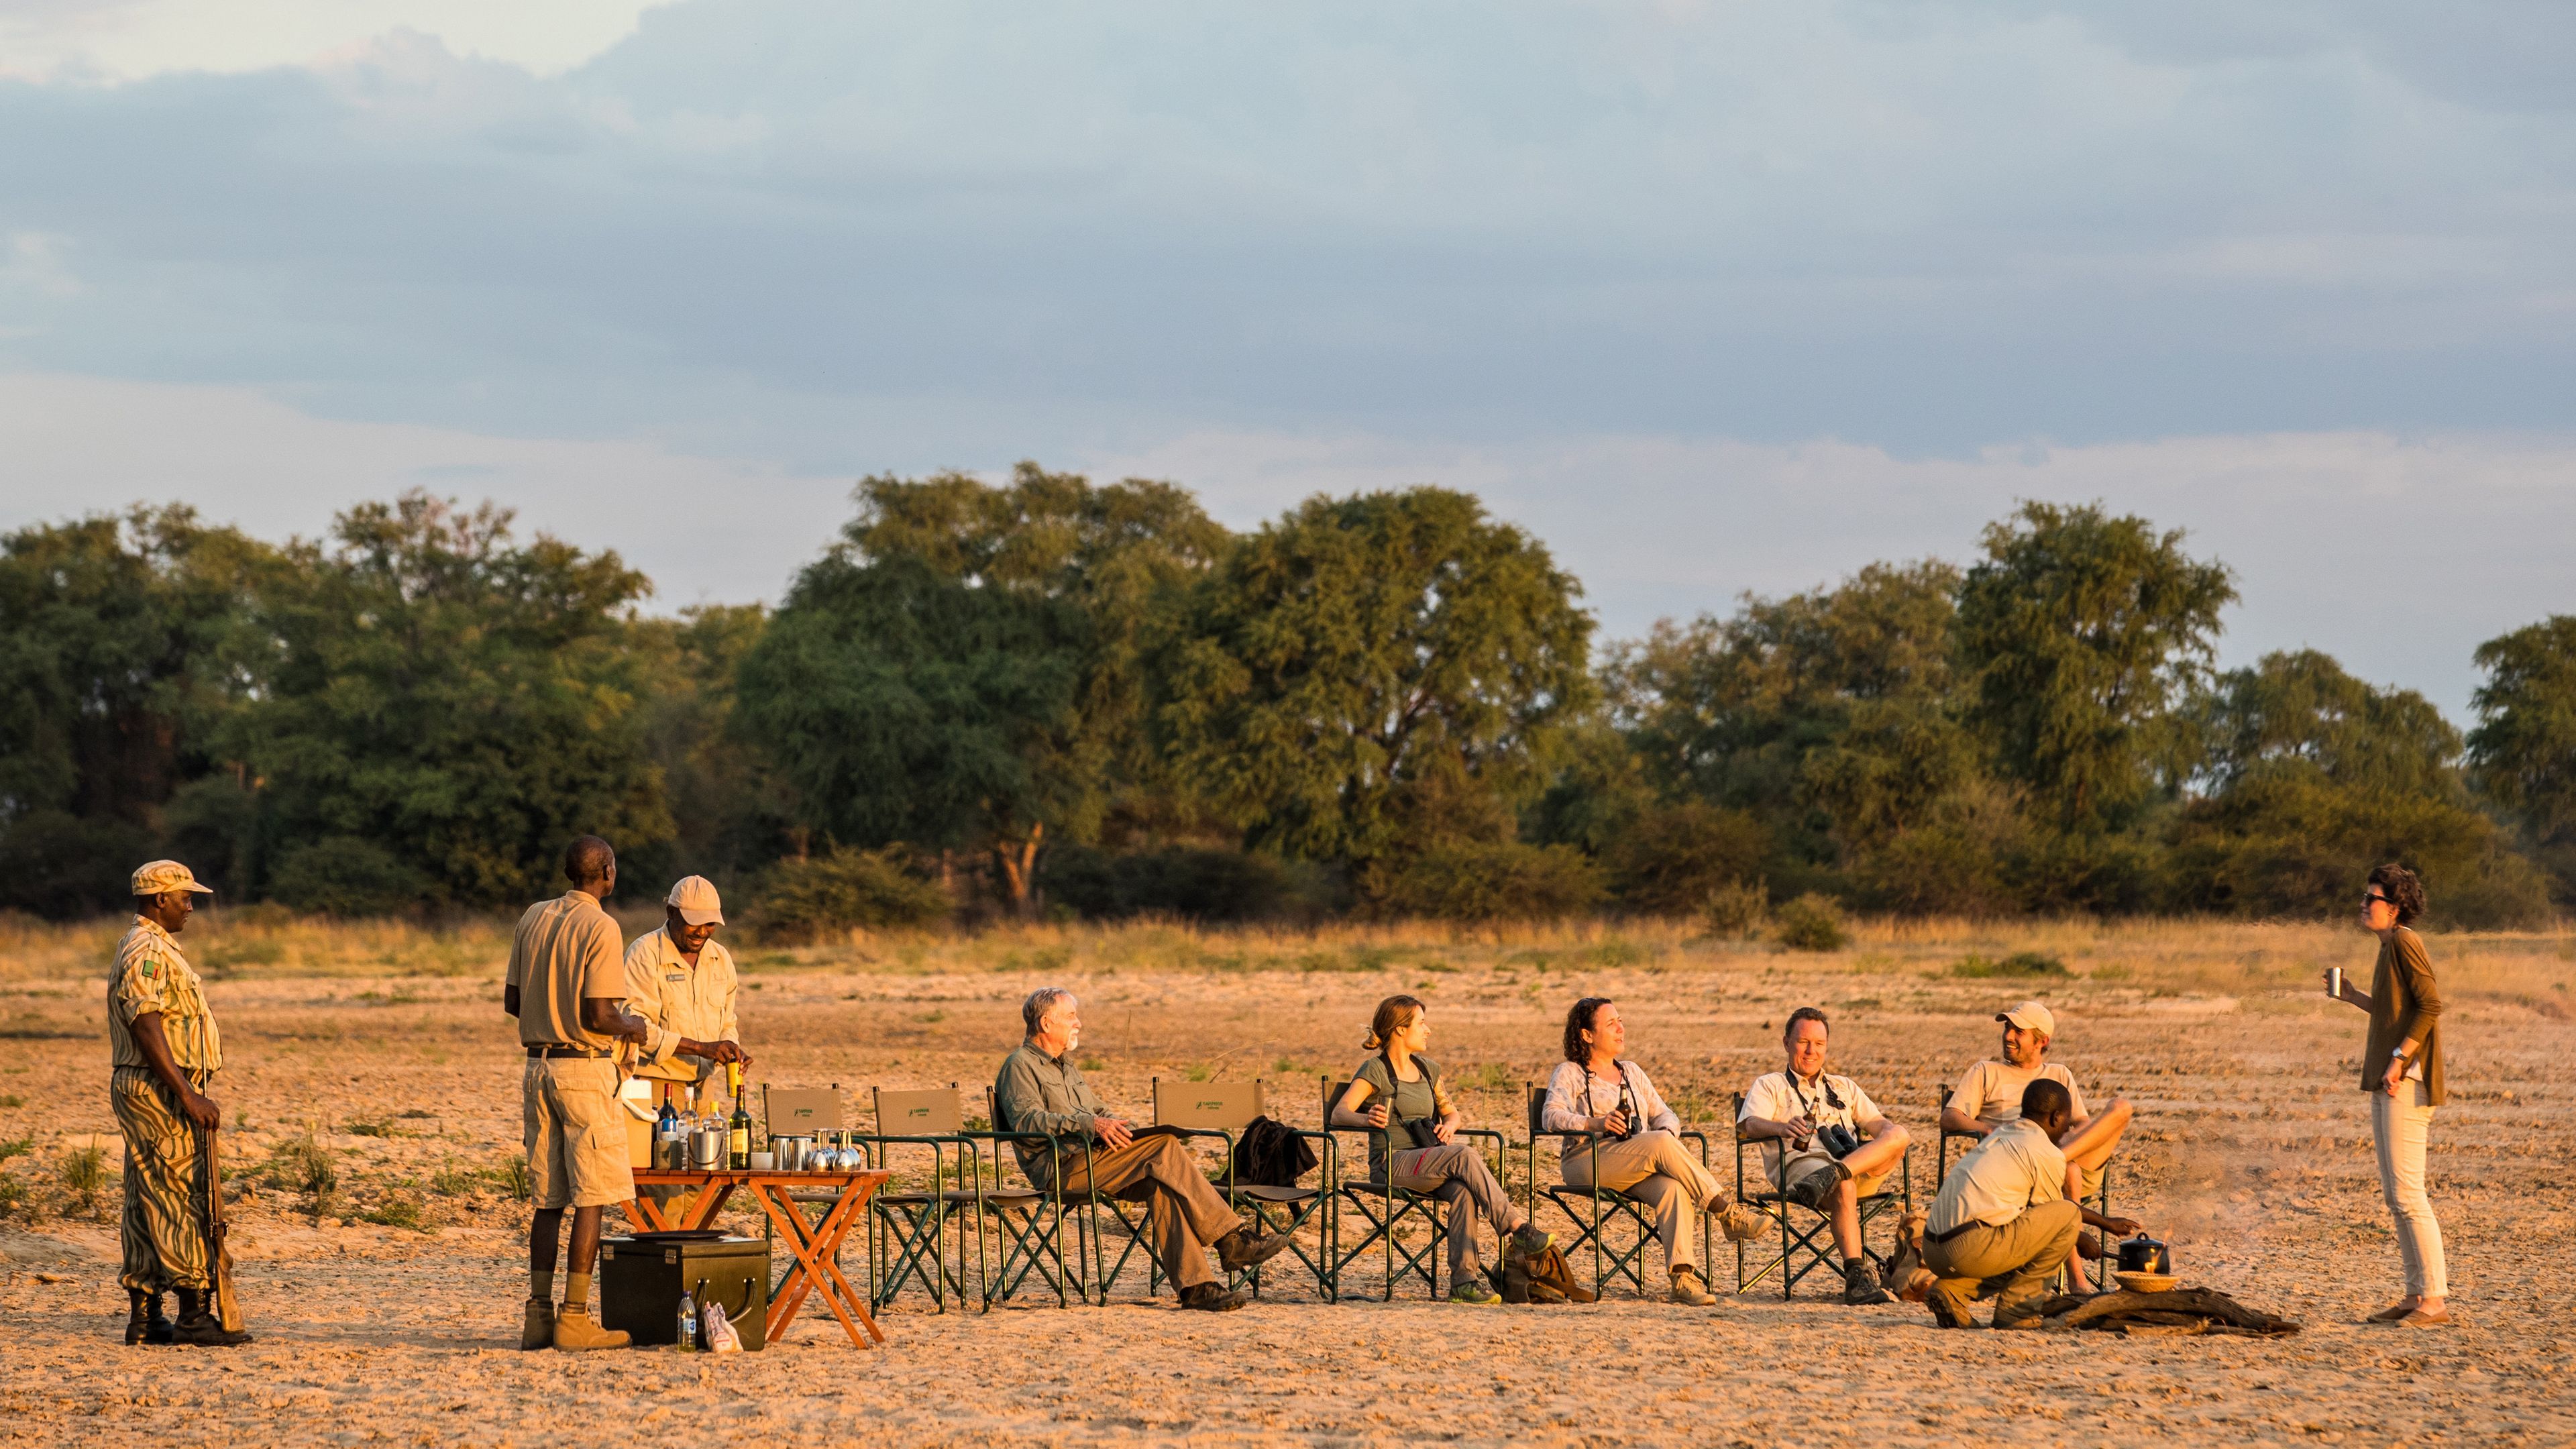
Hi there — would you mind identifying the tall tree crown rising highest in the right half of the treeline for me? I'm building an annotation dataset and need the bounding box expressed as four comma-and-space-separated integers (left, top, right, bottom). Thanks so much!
1955, 502, 2236, 833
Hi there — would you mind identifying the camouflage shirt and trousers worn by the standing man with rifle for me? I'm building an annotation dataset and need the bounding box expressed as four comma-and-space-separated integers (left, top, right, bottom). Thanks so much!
108, 915, 224, 1294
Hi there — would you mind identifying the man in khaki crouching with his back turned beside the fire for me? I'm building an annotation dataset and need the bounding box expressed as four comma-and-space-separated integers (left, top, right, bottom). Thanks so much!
1924, 1078, 2084, 1328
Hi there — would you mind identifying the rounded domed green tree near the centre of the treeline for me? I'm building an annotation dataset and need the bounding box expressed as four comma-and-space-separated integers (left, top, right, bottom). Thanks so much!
1159, 487, 1595, 864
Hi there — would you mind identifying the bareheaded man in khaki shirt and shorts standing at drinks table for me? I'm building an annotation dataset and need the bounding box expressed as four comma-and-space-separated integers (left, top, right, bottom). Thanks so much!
500, 835, 665, 1348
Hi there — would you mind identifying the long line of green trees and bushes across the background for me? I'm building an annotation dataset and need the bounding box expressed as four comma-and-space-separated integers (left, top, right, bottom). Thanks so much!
0, 464, 2576, 933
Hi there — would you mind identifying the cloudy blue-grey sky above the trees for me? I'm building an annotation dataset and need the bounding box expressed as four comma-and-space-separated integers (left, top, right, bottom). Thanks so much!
0, 0, 2576, 722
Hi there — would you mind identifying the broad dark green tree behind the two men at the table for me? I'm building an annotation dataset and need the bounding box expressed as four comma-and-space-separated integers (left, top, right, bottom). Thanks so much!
227, 492, 669, 910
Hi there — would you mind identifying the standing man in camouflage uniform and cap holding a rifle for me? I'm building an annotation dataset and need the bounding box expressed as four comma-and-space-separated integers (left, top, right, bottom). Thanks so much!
108, 861, 250, 1348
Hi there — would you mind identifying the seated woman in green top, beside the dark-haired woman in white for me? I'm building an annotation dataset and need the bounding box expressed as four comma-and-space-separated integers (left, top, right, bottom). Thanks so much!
1332, 996, 1556, 1305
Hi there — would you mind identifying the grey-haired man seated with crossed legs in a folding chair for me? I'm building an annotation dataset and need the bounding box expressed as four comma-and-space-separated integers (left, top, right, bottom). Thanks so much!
991, 985, 1291, 1312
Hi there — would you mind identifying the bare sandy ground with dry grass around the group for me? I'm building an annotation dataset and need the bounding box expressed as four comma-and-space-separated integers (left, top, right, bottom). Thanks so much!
0, 926, 2576, 1446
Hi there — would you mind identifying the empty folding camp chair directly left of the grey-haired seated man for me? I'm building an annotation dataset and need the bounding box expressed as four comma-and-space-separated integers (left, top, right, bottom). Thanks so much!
861, 1083, 984, 1312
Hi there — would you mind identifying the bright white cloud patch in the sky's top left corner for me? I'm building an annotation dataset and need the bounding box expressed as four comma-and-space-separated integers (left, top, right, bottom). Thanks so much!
0, 0, 669, 83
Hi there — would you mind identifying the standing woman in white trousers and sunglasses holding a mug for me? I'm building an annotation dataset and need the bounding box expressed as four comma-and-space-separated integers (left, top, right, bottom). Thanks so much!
2326, 866, 2450, 1328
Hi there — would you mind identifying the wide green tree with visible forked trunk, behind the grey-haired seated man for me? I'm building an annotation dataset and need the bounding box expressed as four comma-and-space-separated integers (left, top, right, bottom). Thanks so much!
742, 464, 1226, 910
